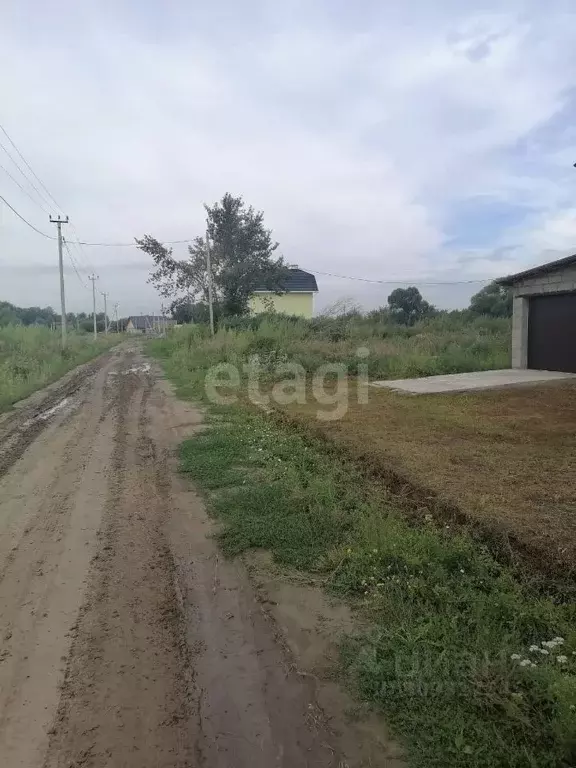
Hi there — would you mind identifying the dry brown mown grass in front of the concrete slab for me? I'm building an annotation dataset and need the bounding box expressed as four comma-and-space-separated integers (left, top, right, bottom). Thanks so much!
276, 383, 576, 576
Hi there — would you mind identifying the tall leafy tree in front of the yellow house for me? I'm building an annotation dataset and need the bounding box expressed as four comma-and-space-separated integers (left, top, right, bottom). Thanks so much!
136, 193, 287, 315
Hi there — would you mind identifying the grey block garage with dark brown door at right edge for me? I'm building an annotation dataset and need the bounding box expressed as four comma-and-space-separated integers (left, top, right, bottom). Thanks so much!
498, 255, 576, 373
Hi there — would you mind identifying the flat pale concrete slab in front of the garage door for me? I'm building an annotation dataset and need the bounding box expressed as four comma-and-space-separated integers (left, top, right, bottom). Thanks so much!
370, 368, 576, 395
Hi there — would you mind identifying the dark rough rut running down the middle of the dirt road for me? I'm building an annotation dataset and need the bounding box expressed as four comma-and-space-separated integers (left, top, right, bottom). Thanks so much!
45, 360, 193, 768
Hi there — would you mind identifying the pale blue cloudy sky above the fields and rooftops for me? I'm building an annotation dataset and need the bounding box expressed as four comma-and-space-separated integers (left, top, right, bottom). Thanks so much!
0, 0, 576, 316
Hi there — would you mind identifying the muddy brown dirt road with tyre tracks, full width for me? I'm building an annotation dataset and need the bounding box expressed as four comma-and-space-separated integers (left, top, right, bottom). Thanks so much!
0, 345, 400, 768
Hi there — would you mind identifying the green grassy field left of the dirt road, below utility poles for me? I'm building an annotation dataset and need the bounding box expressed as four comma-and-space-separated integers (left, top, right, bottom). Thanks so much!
0, 326, 118, 412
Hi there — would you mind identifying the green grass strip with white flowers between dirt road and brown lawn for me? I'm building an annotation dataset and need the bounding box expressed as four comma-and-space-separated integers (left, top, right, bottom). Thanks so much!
182, 409, 576, 768
